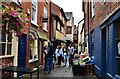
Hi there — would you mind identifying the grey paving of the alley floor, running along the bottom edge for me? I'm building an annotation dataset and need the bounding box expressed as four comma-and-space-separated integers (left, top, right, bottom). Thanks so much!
26, 62, 98, 79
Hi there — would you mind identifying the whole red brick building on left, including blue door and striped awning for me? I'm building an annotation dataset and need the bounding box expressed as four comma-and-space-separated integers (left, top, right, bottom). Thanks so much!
0, 0, 50, 77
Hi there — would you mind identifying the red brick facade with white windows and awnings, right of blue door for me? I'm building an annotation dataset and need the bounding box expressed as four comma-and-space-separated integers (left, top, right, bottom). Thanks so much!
22, 0, 50, 67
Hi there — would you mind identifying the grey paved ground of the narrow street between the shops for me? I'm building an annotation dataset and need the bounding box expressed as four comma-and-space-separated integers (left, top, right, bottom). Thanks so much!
40, 66, 97, 79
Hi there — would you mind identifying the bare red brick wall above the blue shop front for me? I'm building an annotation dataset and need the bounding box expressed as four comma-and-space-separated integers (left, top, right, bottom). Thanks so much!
89, 2, 120, 30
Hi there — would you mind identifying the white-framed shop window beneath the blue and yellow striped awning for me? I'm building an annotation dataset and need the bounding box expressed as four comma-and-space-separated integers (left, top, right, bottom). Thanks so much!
29, 39, 38, 62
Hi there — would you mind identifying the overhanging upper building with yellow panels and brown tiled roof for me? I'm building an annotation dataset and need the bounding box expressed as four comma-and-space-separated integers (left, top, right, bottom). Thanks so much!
50, 2, 67, 47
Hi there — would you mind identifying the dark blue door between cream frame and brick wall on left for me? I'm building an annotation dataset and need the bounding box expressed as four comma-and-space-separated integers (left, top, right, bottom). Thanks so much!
18, 34, 26, 76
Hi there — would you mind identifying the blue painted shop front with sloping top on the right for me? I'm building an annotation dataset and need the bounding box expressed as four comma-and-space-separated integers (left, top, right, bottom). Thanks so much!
89, 9, 120, 79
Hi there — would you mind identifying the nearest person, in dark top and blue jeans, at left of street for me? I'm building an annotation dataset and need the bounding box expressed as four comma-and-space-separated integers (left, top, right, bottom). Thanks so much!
45, 42, 54, 73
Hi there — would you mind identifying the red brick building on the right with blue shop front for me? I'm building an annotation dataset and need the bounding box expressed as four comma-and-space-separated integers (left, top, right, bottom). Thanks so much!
83, 0, 120, 79
